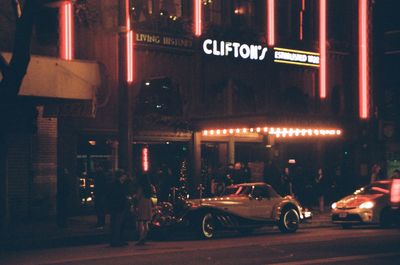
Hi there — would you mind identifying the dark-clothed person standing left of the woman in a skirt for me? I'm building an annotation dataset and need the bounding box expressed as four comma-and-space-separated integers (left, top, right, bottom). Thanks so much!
110, 169, 129, 247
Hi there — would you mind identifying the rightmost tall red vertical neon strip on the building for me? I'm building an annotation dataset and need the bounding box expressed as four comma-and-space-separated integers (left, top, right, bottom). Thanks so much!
358, 0, 369, 119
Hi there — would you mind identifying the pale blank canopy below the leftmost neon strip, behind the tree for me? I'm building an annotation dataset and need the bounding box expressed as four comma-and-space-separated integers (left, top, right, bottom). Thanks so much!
2, 53, 101, 100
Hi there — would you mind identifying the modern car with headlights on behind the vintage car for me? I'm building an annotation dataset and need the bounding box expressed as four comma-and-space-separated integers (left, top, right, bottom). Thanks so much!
332, 180, 394, 228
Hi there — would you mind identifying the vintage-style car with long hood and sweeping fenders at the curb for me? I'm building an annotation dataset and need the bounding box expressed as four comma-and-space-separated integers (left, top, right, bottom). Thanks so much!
152, 182, 311, 239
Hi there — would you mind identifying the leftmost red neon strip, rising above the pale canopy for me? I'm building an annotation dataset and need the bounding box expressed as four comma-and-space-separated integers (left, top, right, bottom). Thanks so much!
59, 2, 74, 60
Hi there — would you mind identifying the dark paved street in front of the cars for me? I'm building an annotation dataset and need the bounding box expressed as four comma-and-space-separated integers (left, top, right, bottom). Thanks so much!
0, 227, 400, 265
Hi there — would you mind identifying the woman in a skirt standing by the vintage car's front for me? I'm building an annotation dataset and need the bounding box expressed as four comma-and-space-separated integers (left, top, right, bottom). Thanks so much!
136, 174, 153, 246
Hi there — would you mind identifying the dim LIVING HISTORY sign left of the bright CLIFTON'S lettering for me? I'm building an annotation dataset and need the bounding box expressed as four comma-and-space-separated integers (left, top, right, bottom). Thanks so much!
135, 33, 193, 49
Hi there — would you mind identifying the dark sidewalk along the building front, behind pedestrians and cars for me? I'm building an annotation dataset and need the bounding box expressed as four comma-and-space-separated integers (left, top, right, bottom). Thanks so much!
0, 211, 333, 251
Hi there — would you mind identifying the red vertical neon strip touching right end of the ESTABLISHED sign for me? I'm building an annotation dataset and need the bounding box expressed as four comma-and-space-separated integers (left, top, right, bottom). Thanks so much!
319, 0, 326, 99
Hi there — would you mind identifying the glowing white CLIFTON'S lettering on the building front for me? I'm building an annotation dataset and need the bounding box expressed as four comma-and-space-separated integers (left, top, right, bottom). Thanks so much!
203, 39, 268, 61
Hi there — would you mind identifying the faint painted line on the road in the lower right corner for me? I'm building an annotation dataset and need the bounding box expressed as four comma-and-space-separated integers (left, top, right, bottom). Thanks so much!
267, 252, 400, 265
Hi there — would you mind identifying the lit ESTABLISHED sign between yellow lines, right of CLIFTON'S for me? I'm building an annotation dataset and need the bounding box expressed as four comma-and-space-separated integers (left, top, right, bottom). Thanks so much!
274, 47, 320, 67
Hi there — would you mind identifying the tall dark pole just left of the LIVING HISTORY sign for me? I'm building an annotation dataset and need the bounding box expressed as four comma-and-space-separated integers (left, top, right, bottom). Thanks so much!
118, 0, 133, 174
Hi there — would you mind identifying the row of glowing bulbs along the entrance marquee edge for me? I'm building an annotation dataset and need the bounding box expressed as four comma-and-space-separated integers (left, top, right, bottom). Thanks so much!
202, 127, 342, 138
